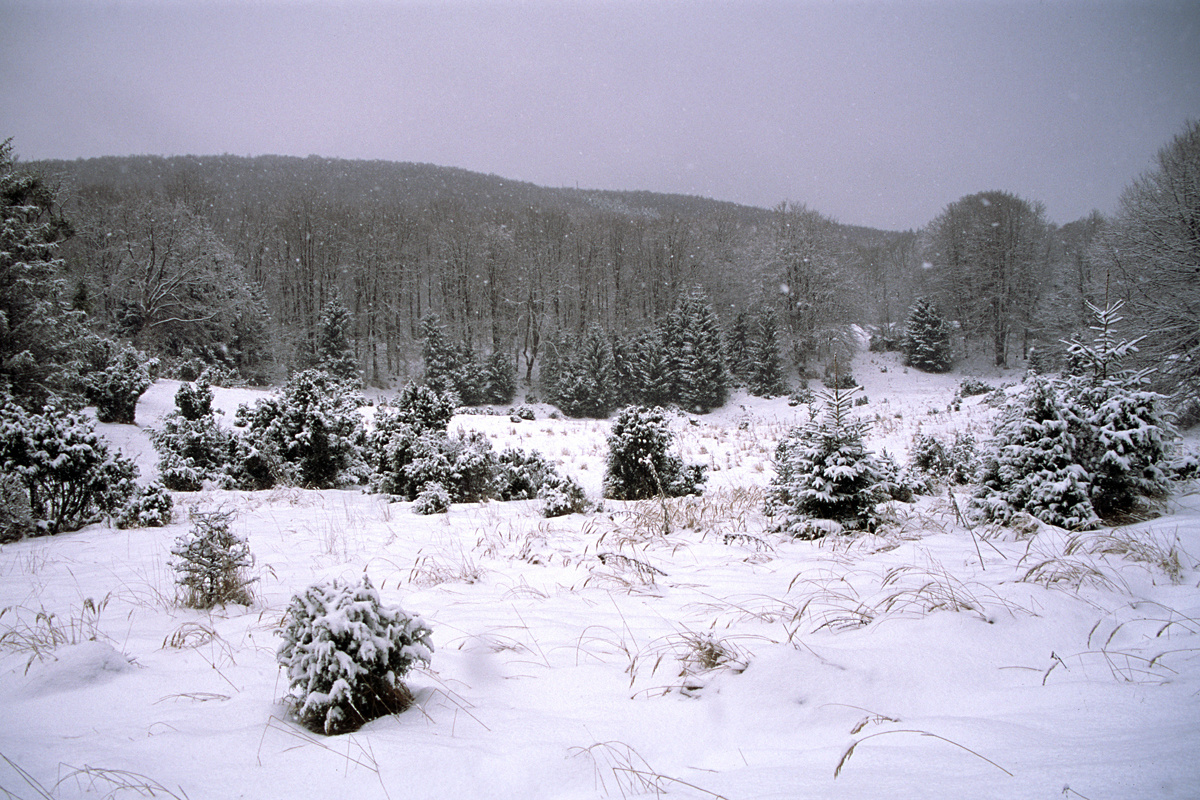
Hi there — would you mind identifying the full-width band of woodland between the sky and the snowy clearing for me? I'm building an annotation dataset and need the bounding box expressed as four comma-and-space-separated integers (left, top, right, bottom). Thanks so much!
9, 122, 1200, 407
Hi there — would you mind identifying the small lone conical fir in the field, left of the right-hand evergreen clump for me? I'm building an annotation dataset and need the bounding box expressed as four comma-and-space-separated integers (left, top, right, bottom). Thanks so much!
768, 389, 883, 535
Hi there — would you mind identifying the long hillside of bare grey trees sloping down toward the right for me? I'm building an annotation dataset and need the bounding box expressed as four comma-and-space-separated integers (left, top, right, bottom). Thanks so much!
24, 155, 912, 383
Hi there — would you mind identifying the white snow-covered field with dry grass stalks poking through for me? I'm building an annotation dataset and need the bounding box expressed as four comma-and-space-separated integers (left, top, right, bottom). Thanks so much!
0, 354, 1200, 800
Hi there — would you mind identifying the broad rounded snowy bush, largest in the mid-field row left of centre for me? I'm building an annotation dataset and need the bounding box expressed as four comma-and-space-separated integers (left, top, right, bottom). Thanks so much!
236, 369, 362, 488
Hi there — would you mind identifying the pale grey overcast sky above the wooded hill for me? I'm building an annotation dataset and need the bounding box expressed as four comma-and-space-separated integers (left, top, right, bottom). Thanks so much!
0, 0, 1200, 229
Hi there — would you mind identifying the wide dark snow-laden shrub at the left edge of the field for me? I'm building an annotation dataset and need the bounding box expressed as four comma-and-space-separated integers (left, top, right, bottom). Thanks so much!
0, 404, 137, 534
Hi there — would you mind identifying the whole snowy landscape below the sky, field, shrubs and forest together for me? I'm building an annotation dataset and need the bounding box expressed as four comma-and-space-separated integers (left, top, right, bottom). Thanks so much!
0, 121, 1200, 800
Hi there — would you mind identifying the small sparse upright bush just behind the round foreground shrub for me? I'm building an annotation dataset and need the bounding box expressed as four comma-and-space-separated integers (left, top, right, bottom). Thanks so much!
170, 509, 254, 609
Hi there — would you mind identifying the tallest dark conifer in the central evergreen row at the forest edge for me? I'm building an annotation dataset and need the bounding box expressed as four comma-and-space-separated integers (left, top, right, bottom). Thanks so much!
664, 290, 730, 414
